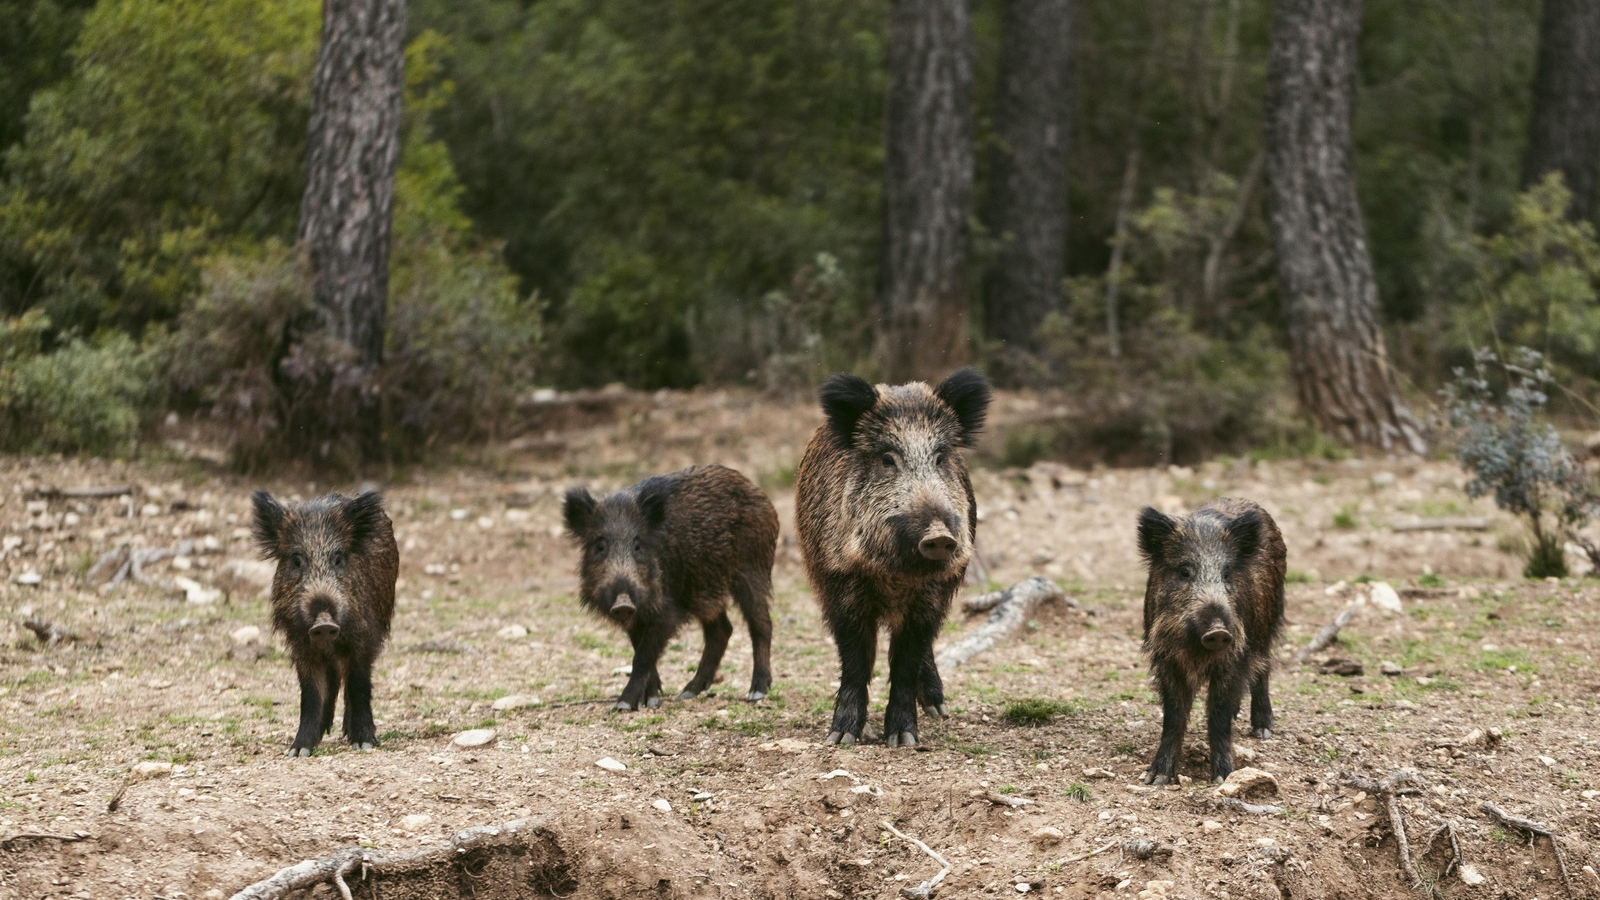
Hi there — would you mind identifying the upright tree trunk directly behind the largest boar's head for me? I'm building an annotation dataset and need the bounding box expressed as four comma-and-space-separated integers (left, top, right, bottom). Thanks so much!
877, 0, 973, 381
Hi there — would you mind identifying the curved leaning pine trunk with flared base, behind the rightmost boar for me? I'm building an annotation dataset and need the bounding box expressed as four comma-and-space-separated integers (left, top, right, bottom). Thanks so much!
1266, 0, 1427, 453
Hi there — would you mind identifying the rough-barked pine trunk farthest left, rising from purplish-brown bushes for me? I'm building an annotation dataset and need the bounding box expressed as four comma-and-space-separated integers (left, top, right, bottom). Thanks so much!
298, 0, 406, 461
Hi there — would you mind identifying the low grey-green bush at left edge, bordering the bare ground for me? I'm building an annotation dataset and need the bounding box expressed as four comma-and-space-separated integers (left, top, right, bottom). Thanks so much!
0, 311, 158, 453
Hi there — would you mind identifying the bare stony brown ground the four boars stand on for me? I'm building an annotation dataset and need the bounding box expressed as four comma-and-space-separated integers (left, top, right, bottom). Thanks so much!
0, 392, 1600, 900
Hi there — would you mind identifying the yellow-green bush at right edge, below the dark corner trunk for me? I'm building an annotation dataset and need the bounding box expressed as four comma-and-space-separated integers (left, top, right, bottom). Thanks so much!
1456, 173, 1600, 378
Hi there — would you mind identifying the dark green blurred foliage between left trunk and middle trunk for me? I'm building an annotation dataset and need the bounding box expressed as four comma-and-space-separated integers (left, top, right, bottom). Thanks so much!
411, 0, 886, 386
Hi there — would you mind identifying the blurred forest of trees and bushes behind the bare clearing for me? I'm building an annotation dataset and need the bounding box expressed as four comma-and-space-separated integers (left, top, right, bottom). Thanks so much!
0, 0, 1600, 468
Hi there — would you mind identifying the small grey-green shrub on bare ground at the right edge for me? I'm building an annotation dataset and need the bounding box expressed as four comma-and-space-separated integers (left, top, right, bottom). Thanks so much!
1445, 348, 1600, 578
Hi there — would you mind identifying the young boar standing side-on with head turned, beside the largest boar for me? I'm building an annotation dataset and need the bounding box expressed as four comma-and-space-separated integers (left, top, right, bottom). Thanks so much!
563, 466, 778, 709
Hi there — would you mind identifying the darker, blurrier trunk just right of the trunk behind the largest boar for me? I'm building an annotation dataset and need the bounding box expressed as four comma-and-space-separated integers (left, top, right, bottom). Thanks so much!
984, 0, 1072, 374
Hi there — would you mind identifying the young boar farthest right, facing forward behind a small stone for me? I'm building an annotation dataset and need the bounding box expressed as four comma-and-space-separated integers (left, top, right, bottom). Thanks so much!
1139, 498, 1286, 785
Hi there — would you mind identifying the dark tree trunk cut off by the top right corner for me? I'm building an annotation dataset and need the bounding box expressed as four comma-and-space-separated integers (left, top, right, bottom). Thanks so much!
1522, 0, 1600, 219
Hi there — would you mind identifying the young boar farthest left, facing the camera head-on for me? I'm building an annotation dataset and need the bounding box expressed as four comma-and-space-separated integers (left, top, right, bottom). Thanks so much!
253, 490, 400, 756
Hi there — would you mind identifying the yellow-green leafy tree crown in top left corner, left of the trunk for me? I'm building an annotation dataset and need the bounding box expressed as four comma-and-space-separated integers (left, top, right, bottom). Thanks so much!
0, 0, 320, 333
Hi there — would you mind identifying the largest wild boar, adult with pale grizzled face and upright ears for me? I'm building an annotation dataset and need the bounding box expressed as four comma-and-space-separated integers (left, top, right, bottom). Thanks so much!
795, 361, 990, 746
